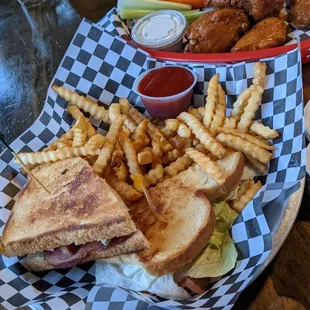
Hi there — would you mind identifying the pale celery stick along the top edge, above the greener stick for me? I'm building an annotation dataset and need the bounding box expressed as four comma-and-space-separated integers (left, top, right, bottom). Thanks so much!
117, 0, 192, 11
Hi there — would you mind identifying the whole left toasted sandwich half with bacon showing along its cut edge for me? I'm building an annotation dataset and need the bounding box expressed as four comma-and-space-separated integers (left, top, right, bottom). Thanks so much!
0, 158, 148, 270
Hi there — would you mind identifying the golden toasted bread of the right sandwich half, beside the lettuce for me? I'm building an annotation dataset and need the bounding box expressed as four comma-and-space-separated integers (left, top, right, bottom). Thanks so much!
130, 152, 244, 276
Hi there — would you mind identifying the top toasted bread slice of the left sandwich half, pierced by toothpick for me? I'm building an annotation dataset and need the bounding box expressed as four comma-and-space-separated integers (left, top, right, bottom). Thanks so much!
0, 158, 136, 256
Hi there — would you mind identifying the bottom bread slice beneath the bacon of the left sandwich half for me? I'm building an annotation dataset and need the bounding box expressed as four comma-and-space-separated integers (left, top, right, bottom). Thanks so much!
24, 231, 149, 271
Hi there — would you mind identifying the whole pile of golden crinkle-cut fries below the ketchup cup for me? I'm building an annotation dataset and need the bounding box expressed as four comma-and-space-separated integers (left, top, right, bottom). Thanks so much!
15, 63, 278, 212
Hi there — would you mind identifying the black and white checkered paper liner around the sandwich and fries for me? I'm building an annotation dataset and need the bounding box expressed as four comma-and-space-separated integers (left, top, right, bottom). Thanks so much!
0, 20, 305, 309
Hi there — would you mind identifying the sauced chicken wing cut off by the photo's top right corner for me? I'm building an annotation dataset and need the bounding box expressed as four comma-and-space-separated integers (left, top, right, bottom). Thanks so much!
288, 0, 310, 28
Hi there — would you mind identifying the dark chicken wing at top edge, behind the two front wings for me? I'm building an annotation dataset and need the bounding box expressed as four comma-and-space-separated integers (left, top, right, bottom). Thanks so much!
231, 0, 284, 21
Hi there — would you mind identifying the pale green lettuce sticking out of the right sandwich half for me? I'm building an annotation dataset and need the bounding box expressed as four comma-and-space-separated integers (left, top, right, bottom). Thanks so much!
176, 201, 238, 278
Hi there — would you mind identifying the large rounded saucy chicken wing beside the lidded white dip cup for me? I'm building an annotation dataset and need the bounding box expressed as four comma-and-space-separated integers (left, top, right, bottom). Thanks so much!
185, 8, 249, 53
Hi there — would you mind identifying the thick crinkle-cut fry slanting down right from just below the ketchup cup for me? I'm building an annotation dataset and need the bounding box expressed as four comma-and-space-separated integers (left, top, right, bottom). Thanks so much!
177, 112, 226, 158
